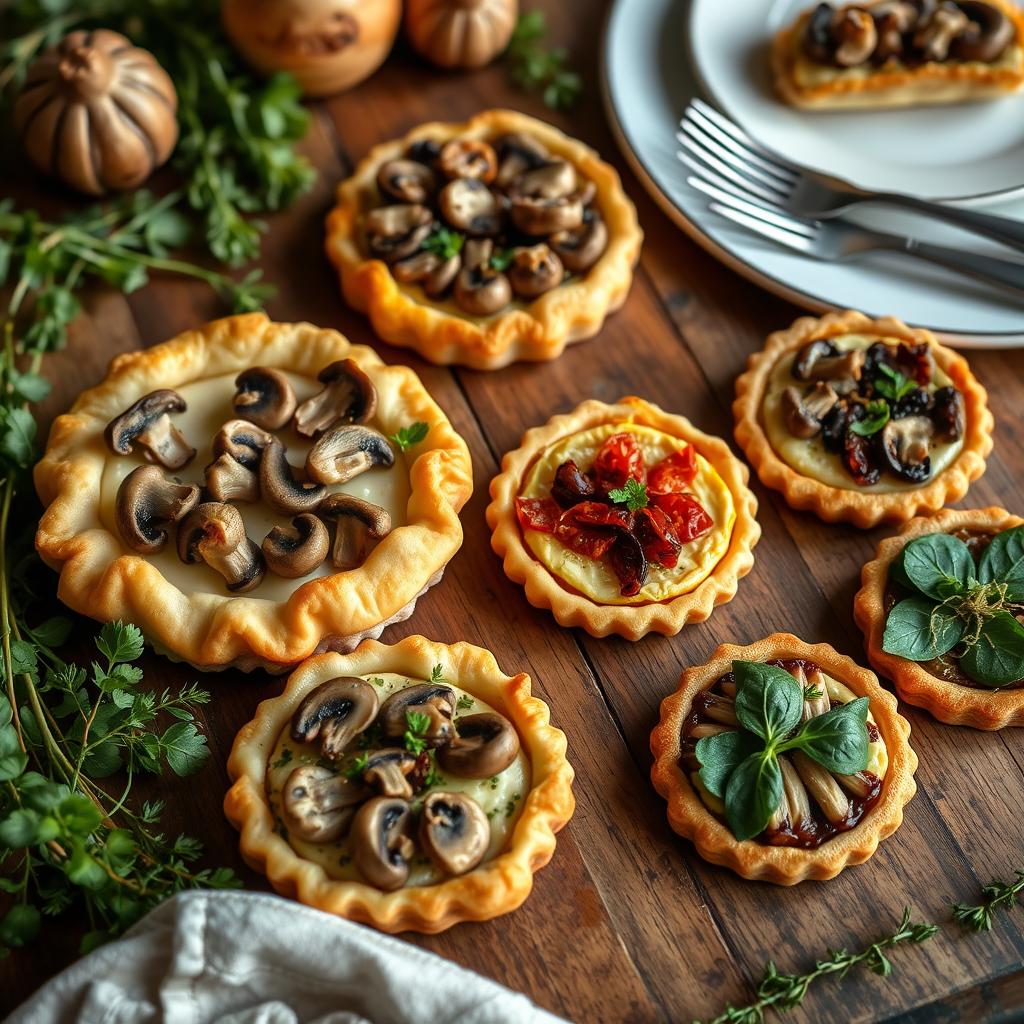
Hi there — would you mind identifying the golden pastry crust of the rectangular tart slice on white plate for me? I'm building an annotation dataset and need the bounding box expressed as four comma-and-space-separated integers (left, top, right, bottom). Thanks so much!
771, 0, 1024, 110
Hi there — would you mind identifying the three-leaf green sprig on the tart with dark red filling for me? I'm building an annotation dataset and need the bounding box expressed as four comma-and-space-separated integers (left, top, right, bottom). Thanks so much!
696, 662, 868, 840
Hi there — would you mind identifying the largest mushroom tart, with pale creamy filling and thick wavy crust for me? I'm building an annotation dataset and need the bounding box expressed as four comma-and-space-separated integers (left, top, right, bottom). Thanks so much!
36, 313, 472, 672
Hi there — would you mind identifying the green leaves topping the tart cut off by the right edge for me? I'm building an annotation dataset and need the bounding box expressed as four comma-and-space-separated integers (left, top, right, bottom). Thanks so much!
882, 526, 1024, 688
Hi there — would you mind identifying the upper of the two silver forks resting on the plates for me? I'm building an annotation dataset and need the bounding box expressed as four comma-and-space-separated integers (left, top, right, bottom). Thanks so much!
676, 98, 1024, 251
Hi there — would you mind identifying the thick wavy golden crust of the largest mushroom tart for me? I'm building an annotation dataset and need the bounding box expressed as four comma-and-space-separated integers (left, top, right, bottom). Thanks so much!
35, 313, 472, 672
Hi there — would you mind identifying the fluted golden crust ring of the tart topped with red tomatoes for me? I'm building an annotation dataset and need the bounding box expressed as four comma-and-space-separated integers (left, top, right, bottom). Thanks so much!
486, 396, 761, 640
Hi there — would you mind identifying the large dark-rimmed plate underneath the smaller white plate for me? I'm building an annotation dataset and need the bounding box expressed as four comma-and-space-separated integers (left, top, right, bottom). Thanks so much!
603, 0, 1024, 347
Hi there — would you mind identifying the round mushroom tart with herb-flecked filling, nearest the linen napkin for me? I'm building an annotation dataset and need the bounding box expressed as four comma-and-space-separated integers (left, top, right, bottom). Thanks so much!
224, 636, 573, 932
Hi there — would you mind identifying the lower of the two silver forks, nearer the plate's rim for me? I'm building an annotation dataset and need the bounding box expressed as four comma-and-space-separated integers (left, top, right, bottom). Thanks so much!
687, 175, 1024, 292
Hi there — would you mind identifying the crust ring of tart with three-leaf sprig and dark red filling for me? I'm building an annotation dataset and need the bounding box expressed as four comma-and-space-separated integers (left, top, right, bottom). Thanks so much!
650, 633, 918, 886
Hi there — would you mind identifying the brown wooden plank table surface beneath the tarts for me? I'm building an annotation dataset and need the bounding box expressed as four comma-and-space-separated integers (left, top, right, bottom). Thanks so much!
0, 0, 1024, 1022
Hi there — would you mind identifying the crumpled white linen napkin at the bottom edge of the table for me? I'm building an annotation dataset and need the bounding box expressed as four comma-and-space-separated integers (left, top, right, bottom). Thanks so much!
7, 892, 565, 1024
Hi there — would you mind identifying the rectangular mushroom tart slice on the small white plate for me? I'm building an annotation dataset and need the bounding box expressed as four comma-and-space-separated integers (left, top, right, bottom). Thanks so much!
772, 0, 1024, 110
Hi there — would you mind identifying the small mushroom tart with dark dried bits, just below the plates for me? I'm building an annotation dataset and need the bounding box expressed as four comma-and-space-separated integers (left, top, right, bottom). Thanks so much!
733, 311, 992, 528
